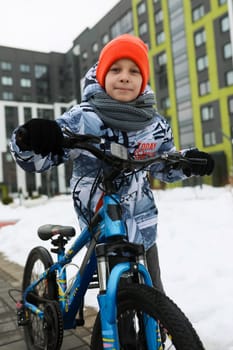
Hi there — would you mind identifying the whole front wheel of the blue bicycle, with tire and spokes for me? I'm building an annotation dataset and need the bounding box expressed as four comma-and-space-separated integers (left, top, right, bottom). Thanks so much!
91, 285, 204, 350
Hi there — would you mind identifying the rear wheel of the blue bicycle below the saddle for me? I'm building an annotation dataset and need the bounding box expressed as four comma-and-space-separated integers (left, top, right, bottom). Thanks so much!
22, 247, 63, 350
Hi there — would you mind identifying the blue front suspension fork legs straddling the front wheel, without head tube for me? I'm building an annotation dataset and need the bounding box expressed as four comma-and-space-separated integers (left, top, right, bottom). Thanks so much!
96, 243, 162, 350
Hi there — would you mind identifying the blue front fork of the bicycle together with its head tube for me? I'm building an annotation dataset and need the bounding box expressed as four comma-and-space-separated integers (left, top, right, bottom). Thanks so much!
96, 193, 162, 350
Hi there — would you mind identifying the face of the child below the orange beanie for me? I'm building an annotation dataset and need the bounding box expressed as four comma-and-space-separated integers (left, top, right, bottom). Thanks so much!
105, 58, 142, 102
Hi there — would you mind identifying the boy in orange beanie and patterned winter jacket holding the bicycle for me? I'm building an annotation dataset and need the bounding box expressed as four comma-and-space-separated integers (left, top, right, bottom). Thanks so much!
11, 34, 214, 291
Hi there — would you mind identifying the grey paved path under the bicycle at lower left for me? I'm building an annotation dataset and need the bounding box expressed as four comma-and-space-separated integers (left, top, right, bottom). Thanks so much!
0, 253, 96, 350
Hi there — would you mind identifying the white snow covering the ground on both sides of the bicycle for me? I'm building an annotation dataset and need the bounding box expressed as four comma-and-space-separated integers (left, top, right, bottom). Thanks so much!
0, 186, 233, 350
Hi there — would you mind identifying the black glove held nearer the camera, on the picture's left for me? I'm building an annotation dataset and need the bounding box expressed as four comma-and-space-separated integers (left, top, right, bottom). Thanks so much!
16, 119, 64, 157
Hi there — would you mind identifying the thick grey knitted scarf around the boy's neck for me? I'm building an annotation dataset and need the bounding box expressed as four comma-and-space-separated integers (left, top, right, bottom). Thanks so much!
88, 92, 155, 132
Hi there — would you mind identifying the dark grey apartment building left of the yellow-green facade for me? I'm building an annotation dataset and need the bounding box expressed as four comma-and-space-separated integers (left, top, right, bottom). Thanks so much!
0, 0, 133, 195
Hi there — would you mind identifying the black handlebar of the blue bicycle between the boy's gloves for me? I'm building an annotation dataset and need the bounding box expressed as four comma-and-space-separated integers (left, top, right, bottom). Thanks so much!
63, 129, 207, 170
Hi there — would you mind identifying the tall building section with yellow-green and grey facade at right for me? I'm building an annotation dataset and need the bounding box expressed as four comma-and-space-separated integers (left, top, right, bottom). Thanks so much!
132, 0, 233, 185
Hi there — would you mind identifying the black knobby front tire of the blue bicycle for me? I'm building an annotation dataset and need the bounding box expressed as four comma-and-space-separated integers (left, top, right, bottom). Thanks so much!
91, 285, 204, 350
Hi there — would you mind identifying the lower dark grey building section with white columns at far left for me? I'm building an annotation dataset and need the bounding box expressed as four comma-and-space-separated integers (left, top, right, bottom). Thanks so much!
0, 46, 74, 197
